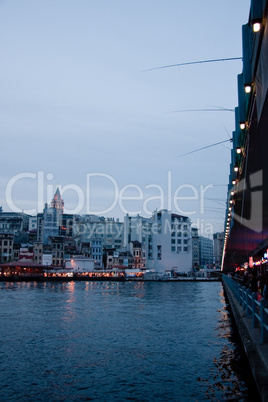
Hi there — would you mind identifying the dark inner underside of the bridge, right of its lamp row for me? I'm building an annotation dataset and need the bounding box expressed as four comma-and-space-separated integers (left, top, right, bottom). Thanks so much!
224, 9, 268, 268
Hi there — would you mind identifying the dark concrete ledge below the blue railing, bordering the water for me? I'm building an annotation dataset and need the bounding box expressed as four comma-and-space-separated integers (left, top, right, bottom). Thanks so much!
222, 275, 268, 401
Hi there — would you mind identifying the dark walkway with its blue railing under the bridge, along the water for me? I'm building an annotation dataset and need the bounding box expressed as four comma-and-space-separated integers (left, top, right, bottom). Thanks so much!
222, 275, 268, 401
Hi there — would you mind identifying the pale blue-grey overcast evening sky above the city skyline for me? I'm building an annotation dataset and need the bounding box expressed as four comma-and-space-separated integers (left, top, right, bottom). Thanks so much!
0, 0, 250, 237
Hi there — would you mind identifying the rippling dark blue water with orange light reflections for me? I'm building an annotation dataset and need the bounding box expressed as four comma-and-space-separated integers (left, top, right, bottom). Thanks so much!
0, 282, 259, 402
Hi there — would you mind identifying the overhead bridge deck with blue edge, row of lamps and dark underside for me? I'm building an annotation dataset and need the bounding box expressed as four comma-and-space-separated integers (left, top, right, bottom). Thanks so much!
222, 0, 268, 272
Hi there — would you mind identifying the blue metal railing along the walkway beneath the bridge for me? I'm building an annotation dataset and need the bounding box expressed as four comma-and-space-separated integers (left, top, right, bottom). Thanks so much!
222, 275, 268, 343
